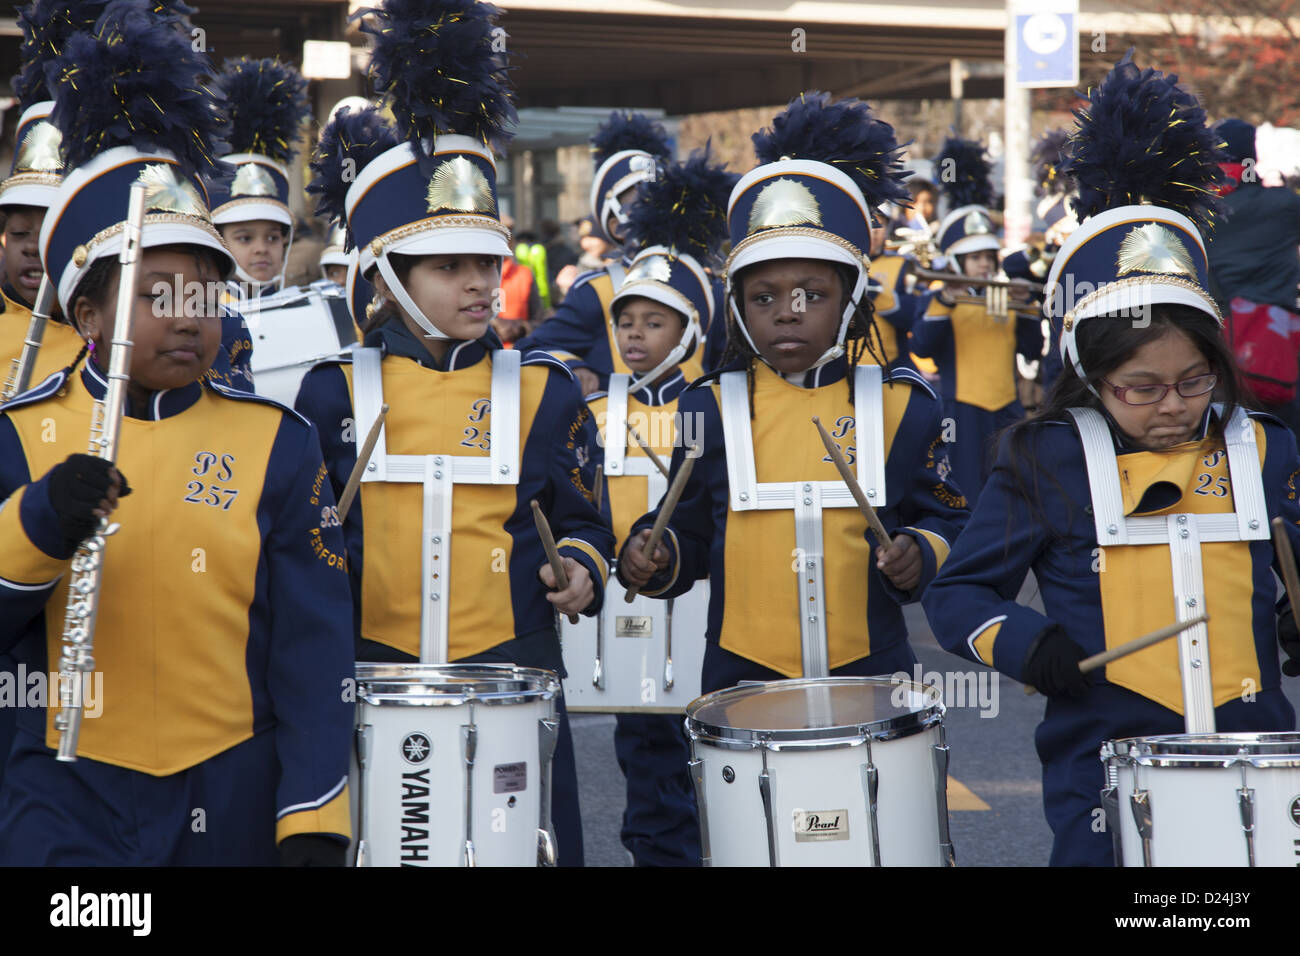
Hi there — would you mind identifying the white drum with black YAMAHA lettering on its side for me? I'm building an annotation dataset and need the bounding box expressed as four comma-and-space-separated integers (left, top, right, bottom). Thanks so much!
352, 663, 560, 866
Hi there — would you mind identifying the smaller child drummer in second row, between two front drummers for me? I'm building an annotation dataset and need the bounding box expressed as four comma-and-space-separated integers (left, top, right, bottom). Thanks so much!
588, 147, 737, 866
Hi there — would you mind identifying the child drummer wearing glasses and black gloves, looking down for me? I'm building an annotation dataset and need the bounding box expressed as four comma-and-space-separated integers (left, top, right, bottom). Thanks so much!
923, 56, 1300, 865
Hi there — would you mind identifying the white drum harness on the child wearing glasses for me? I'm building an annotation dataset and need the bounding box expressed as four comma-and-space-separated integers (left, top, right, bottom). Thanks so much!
1070, 408, 1269, 734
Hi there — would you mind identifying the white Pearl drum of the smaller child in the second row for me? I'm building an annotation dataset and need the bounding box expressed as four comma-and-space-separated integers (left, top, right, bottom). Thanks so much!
560, 574, 709, 714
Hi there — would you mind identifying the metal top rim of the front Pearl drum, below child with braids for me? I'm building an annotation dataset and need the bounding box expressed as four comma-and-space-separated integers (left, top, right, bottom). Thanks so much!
685, 676, 946, 750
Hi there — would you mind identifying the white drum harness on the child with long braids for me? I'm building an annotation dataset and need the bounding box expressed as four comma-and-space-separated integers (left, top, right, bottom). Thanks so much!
717, 365, 887, 678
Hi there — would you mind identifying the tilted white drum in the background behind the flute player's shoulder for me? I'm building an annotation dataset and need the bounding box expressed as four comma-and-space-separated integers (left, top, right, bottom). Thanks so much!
244, 282, 356, 407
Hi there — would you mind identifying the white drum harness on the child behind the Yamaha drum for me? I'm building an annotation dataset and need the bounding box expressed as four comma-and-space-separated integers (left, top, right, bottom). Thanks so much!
352, 349, 520, 663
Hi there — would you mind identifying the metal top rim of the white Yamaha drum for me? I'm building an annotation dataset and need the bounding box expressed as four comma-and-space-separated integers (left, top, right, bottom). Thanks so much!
356, 662, 560, 708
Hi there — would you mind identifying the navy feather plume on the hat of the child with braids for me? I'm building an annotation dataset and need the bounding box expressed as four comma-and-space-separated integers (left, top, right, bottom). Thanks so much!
753, 92, 911, 208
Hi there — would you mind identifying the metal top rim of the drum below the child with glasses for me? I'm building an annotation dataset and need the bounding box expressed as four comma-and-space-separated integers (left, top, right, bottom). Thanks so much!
1101, 731, 1300, 769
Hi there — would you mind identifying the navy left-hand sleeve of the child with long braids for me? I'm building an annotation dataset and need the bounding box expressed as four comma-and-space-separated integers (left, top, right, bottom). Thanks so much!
620, 388, 727, 598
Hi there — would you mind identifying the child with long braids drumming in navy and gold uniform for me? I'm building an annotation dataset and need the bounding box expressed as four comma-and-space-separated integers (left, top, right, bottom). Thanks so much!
619, 94, 966, 692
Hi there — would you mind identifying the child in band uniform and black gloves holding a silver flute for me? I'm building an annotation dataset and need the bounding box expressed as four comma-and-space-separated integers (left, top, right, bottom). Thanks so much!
0, 0, 352, 865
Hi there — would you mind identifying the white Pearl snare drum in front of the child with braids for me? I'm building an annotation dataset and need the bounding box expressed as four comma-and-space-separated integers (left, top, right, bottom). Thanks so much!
686, 678, 954, 866
